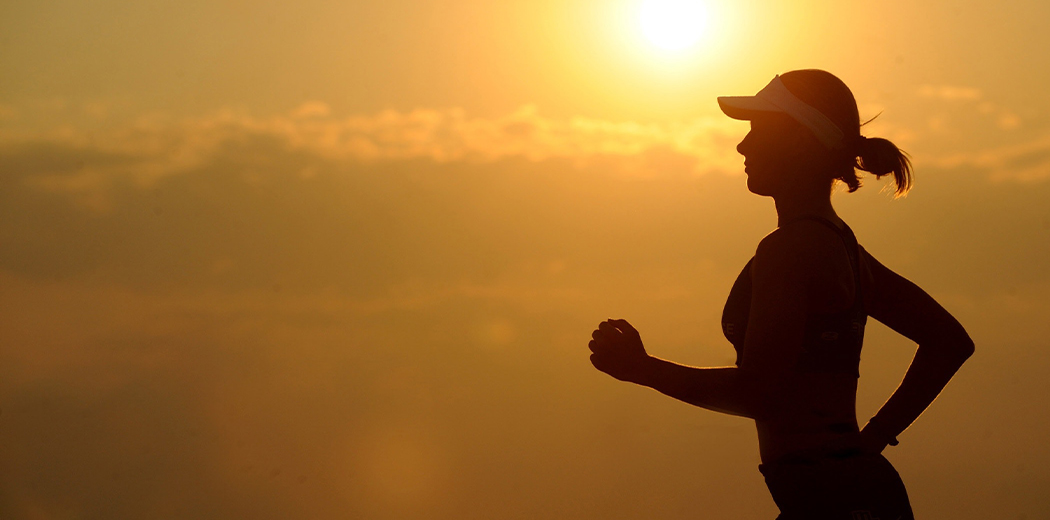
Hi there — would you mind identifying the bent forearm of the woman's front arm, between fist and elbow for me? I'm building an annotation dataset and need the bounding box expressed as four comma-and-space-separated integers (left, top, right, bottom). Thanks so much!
635, 357, 763, 418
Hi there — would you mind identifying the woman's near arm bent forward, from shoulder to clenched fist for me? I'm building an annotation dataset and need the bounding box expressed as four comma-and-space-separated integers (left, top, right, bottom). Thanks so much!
590, 227, 818, 419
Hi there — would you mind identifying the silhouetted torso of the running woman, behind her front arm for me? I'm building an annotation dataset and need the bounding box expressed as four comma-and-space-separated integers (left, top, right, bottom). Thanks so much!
722, 216, 867, 462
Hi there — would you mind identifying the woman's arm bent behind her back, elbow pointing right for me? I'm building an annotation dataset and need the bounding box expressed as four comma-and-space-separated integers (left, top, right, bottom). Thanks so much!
863, 251, 973, 444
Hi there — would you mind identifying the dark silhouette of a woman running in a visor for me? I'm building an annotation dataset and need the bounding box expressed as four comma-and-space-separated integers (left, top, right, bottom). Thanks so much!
589, 69, 973, 520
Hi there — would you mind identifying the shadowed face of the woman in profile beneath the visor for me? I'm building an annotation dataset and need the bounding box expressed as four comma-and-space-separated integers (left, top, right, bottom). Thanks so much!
736, 112, 810, 196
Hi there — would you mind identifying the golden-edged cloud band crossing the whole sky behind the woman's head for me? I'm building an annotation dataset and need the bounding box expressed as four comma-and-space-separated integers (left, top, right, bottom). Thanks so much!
0, 92, 1050, 196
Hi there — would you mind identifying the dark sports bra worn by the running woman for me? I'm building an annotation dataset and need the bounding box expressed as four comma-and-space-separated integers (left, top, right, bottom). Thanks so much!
721, 215, 867, 377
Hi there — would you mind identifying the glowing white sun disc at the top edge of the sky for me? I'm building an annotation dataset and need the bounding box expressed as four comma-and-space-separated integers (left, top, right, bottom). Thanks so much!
637, 0, 708, 51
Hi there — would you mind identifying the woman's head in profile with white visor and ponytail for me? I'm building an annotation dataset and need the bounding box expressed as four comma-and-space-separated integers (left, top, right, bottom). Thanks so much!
718, 69, 911, 196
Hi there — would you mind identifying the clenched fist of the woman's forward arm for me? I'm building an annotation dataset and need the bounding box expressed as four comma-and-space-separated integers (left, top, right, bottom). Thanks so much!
587, 319, 652, 384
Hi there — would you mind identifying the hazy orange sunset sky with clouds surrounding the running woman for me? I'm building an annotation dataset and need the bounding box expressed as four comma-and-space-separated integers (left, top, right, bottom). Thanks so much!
0, 0, 1050, 520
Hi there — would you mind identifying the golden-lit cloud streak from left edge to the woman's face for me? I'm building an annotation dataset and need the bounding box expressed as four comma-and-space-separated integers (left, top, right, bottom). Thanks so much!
0, 106, 746, 191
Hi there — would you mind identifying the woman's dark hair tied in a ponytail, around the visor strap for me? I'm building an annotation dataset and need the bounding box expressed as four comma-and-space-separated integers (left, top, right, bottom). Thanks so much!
780, 69, 911, 199
